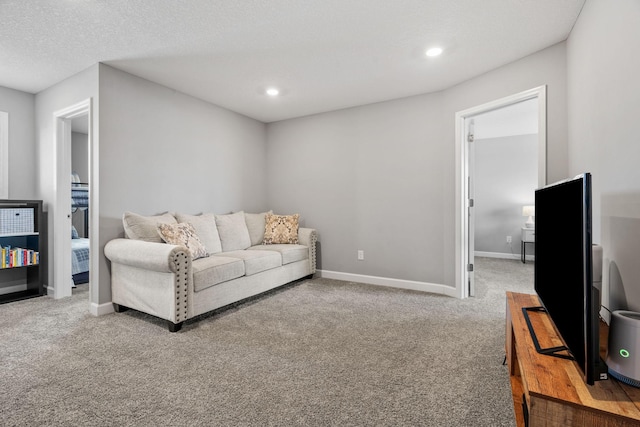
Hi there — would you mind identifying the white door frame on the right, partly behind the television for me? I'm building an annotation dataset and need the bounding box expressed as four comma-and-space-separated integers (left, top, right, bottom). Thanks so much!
455, 85, 547, 298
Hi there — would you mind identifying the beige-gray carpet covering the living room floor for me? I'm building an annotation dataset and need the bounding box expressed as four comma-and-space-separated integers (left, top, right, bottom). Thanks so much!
0, 259, 533, 426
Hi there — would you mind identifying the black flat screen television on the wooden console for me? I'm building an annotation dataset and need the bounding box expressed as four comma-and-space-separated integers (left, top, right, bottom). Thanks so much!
534, 173, 607, 385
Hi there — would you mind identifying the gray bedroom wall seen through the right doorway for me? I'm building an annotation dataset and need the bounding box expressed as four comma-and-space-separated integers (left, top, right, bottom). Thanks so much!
474, 134, 538, 257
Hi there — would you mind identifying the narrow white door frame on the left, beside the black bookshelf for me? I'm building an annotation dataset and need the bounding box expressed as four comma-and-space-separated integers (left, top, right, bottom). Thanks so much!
48, 98, 92, 299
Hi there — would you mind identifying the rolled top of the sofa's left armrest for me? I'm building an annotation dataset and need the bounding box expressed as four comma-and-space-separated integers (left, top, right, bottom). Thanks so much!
104, 239, 191, 273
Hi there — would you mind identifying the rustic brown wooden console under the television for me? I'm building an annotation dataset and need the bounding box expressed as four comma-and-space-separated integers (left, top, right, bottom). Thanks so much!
506, 292, 640, 427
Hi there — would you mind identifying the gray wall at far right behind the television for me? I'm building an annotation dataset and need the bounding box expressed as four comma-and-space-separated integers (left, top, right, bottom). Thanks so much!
567, 0, 640, 311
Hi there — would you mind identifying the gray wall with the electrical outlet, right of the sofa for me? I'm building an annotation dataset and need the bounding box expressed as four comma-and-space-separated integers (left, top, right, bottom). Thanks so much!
268, 94, 445, 283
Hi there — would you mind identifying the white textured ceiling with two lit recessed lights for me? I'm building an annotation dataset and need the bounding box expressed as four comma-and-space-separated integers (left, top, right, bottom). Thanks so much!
0, 0, 585, 122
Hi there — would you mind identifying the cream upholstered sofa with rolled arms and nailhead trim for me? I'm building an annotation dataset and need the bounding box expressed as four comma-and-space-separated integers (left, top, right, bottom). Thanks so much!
104, 212, 317, 332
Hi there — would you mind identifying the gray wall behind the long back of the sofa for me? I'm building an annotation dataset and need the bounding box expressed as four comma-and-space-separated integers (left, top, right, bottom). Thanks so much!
99, 64, 267, 303
